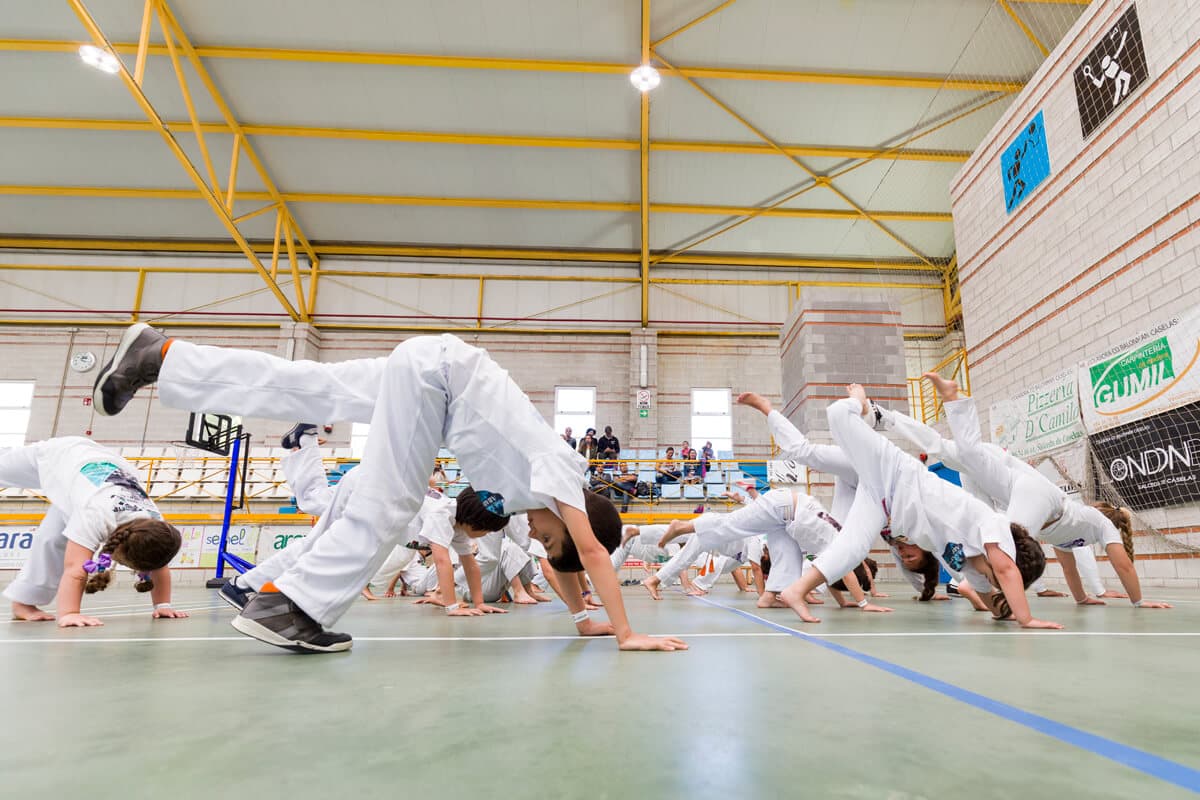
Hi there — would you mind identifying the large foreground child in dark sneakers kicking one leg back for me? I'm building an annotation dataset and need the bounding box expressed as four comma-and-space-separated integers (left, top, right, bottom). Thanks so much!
92, 324, 686, 652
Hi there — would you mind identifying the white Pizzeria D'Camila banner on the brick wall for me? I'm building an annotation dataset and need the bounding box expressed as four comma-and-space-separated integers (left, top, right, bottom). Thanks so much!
989, 368, 1084, 459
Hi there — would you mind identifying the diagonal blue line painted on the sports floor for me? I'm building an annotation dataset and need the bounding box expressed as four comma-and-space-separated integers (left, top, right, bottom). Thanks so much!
695, 597, 1200, 793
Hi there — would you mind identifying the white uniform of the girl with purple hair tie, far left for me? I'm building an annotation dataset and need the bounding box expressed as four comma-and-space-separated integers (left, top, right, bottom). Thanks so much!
0, 437, 162, 606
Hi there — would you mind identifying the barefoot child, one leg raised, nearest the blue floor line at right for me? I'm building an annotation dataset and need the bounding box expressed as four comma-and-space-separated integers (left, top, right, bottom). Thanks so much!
782, 384, 1062, 628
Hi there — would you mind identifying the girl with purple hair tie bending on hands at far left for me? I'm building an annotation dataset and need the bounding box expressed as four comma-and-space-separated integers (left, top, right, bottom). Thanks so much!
0, 437, 187, 627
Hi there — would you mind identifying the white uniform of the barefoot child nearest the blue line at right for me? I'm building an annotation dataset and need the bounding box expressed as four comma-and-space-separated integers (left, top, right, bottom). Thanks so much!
814, 397, 1016, 591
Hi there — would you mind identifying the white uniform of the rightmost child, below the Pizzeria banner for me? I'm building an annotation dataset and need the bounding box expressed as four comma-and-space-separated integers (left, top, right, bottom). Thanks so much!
943, 397, 1121, 566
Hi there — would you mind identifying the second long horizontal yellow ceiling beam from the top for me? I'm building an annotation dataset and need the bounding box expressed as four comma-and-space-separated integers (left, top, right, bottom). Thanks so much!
0, 116, 971, 163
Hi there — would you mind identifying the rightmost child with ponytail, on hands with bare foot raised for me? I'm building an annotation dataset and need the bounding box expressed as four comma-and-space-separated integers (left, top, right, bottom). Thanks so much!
924, 372, 1170, 608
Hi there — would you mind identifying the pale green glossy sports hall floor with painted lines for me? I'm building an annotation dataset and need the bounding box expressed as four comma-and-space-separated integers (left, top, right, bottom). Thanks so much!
0, 582, 1200, 800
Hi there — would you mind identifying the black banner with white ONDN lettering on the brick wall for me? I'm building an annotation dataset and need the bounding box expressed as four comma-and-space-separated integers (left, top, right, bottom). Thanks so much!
1088, 403, 1200, 510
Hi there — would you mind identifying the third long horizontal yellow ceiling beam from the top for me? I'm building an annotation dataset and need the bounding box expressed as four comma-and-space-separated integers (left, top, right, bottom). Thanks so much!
0, 186, 953, 221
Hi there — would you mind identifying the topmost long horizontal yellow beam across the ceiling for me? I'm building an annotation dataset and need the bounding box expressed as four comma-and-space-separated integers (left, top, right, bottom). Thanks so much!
0, 38, 1024, 94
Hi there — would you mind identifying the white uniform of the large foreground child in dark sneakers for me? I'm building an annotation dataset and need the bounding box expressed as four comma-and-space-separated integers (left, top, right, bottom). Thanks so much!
158, 335, 587, 627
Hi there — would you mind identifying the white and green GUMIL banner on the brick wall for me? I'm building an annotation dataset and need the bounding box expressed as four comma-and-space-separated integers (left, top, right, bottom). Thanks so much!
1079, 309, 1200, 433
